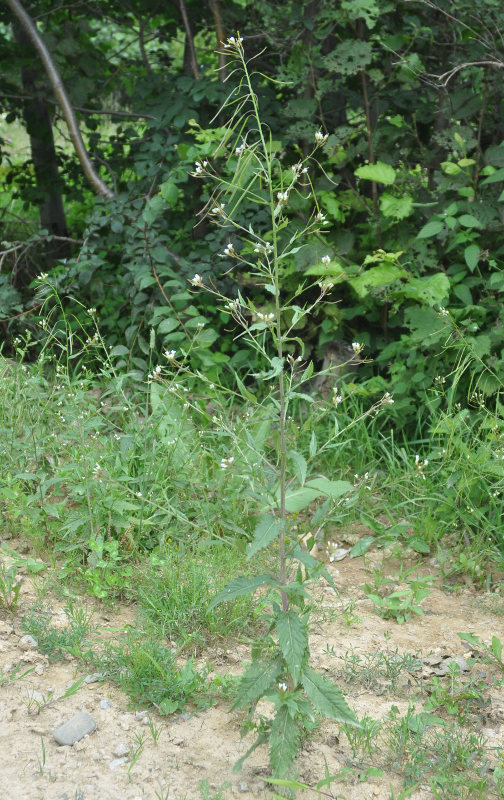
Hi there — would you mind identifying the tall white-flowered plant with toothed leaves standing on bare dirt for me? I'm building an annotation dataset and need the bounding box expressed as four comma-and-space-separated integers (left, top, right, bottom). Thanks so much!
183, 34, 392, 778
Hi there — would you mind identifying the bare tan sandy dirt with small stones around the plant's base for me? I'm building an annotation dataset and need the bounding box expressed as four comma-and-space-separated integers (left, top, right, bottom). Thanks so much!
0, 544, 504, 800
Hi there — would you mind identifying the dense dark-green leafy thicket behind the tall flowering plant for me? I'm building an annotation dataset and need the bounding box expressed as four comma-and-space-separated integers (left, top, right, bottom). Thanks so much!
0, 0, 504, 431
